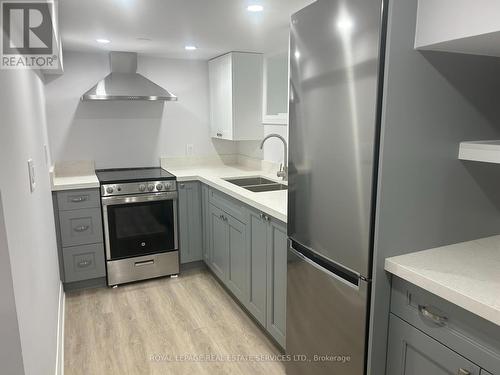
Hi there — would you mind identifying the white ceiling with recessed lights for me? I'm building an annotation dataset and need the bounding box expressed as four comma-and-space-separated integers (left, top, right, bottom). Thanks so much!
59, 0, 313, 59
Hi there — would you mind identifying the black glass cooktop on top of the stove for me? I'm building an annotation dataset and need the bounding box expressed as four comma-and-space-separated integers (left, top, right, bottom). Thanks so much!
96, 167, 175, 184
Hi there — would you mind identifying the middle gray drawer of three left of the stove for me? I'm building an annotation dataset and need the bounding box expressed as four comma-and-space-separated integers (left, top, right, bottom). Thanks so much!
59, 208, 104, 247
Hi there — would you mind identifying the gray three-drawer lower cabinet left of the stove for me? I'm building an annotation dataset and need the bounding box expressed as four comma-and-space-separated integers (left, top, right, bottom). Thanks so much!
53, 189, 106, 291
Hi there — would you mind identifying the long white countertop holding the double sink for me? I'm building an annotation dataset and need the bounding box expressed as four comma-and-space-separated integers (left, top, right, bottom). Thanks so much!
162, 165, 287, 223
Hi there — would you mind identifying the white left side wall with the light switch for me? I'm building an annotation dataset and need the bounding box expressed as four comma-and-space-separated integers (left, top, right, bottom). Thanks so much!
0, 70, 60, 375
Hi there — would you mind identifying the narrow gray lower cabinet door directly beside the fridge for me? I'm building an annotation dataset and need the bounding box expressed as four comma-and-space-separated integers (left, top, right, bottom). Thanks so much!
266, 221, 287, 348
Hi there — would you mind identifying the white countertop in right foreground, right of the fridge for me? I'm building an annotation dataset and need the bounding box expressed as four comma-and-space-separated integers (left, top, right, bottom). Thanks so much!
385, 236, 500, 326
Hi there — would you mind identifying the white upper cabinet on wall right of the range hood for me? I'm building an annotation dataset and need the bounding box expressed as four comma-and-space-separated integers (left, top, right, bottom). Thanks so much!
208, 52, 263, 141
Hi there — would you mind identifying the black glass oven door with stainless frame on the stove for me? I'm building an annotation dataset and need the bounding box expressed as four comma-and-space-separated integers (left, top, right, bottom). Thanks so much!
102, 192, 178, 261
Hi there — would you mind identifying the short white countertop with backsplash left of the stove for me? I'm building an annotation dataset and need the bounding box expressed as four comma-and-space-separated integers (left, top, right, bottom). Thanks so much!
50, 161, 100, 191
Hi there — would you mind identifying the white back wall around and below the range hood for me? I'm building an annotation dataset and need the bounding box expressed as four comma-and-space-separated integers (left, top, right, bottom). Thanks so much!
46, 52, 236, 168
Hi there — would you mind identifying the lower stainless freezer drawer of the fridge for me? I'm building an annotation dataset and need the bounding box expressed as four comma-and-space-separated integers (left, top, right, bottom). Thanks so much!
286, 246, 369, 375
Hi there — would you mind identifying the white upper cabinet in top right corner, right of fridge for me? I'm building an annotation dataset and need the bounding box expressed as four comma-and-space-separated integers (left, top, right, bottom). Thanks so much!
415, 0, 500, 56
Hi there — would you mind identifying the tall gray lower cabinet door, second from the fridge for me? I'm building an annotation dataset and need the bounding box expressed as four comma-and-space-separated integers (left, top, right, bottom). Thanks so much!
246, 210, 268, 327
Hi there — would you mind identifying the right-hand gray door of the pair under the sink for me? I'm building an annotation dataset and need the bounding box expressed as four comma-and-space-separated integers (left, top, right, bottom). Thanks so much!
224, 213, 248, 303
